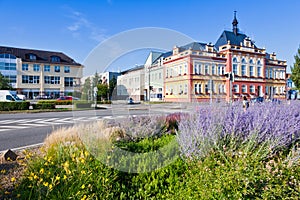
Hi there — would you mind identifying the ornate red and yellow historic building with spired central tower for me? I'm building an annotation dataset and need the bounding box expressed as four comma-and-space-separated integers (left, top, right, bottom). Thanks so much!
162, 13, 287, 102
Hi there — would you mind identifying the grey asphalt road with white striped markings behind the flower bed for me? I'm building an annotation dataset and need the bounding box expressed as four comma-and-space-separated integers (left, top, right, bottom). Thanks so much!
0, 104, 191, 151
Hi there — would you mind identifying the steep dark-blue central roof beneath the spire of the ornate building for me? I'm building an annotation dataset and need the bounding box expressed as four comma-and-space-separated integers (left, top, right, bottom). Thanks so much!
215, 31, 256, 49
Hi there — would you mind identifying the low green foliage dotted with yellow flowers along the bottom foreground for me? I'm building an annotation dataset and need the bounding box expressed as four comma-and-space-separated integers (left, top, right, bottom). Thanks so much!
4, 132, 300, 199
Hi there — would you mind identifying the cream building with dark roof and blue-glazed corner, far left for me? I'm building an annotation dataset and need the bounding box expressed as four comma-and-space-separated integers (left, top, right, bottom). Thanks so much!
0, 46, 83, 99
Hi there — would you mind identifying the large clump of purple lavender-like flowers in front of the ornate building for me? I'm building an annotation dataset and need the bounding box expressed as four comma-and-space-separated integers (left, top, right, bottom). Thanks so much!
177, 102, 300, 158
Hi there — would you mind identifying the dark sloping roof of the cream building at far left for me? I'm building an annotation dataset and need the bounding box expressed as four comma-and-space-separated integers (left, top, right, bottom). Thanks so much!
0, 46, 81, 66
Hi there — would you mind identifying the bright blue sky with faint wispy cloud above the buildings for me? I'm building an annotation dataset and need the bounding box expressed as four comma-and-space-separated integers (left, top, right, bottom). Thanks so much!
0, 0, 300, 75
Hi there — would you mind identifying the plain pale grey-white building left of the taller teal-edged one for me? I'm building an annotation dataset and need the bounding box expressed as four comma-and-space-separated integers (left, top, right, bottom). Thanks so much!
113, 65, 145, 101
